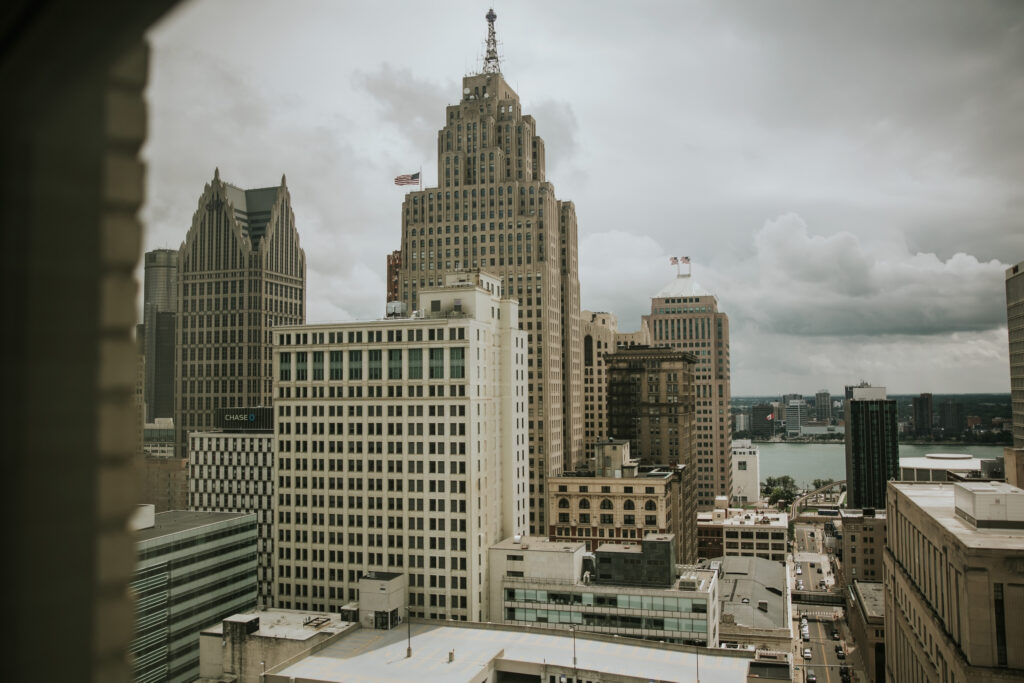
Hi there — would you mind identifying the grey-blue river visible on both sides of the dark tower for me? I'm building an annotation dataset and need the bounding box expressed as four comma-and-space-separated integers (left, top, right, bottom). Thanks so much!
755, 442, 1002, 487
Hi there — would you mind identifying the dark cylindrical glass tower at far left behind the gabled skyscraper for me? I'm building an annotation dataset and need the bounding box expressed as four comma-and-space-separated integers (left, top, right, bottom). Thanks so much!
142, 249, 178, 422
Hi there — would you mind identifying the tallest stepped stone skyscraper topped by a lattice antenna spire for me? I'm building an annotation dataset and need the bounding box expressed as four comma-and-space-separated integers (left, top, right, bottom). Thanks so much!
399, 11, 584, 532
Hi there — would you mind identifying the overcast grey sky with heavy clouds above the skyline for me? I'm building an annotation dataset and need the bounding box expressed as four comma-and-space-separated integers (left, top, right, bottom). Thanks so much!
143, 0, 1024, 395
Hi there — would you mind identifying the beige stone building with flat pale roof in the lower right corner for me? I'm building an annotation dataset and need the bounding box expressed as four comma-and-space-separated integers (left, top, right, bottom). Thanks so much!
884, 481, 1024, 683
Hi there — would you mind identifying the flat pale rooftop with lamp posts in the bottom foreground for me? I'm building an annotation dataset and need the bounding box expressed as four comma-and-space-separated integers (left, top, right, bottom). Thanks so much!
265, 621, 752, 683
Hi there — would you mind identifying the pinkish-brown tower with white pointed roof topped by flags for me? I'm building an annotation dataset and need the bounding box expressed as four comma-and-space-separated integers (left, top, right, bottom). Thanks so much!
643, 272, 732, 509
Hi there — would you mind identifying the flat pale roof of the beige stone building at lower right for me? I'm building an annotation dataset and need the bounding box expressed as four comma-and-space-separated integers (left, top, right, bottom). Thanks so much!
891, 481, 1024, 551
